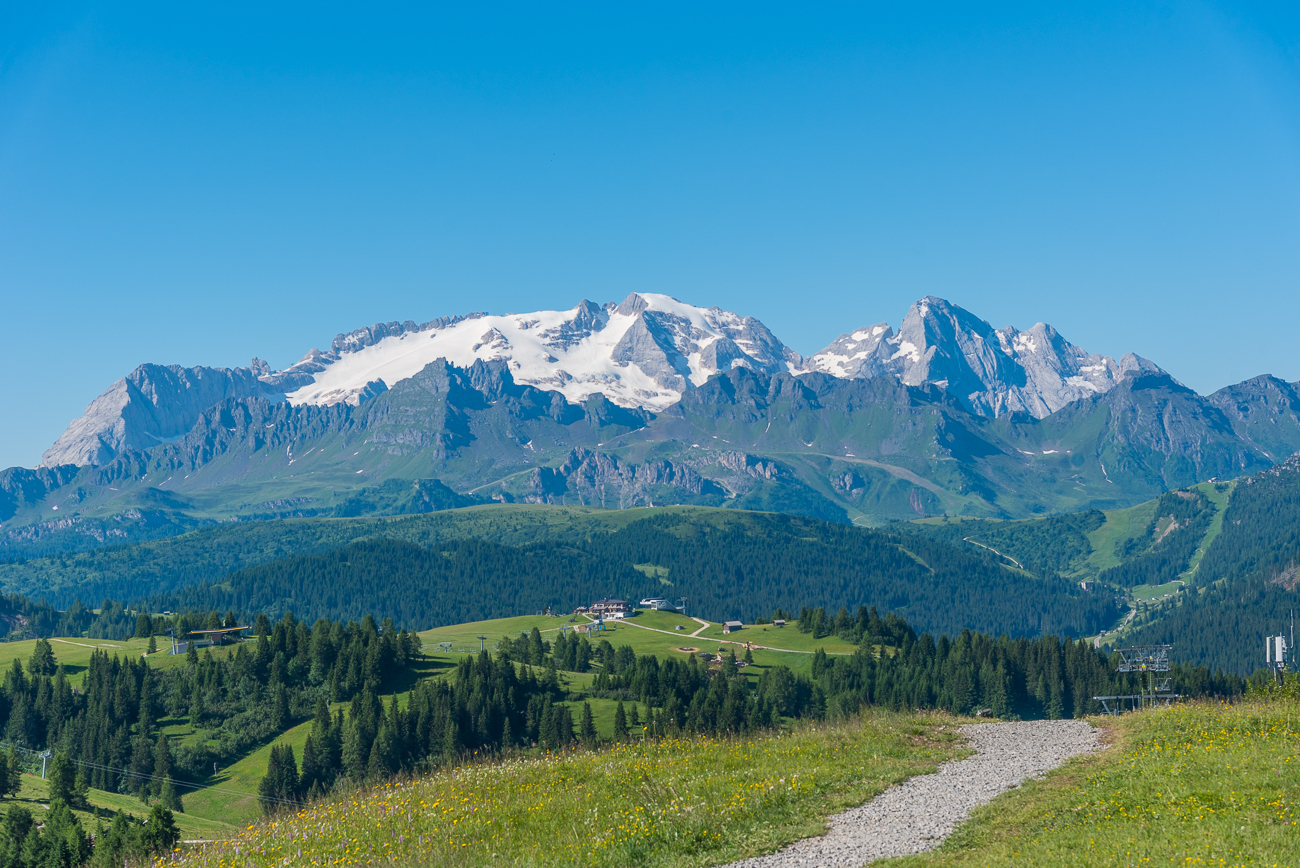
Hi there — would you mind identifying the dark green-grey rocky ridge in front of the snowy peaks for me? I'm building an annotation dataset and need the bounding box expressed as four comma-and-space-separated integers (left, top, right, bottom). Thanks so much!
10, 350, 1300, 551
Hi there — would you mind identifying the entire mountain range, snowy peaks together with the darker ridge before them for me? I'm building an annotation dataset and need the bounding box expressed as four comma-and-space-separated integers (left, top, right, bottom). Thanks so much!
10, 295, 1300, 551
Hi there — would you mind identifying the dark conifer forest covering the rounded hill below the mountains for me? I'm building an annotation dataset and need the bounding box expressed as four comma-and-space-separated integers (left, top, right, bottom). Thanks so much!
154, 513, 1119, 635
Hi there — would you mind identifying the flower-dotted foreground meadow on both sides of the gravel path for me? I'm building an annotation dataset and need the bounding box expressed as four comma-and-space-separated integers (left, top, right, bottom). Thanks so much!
157, 700, 1300, 868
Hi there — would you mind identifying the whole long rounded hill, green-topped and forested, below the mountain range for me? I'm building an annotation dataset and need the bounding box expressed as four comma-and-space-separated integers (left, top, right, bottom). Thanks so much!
0, 507, 1119, 635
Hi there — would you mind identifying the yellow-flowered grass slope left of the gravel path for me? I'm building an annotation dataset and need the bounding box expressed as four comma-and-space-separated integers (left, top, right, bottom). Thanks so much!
167, 712, 959, 867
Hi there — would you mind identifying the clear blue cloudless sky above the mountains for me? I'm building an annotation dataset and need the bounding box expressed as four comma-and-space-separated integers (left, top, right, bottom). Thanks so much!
0, 3, 1300, 466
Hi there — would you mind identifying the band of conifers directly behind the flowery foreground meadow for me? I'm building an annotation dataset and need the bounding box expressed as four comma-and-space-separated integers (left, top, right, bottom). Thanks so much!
259, 607, 1244, 811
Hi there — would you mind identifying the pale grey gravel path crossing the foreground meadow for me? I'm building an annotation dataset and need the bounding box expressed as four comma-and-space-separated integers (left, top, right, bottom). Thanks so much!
725, 720, 1101, 868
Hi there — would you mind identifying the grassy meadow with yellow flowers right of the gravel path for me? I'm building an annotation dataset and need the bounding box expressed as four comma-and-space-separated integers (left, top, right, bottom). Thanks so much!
887, 702, 1300, 868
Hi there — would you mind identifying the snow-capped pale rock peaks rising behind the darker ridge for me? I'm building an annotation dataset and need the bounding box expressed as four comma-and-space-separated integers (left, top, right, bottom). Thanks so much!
42, 294, 1160, 466
